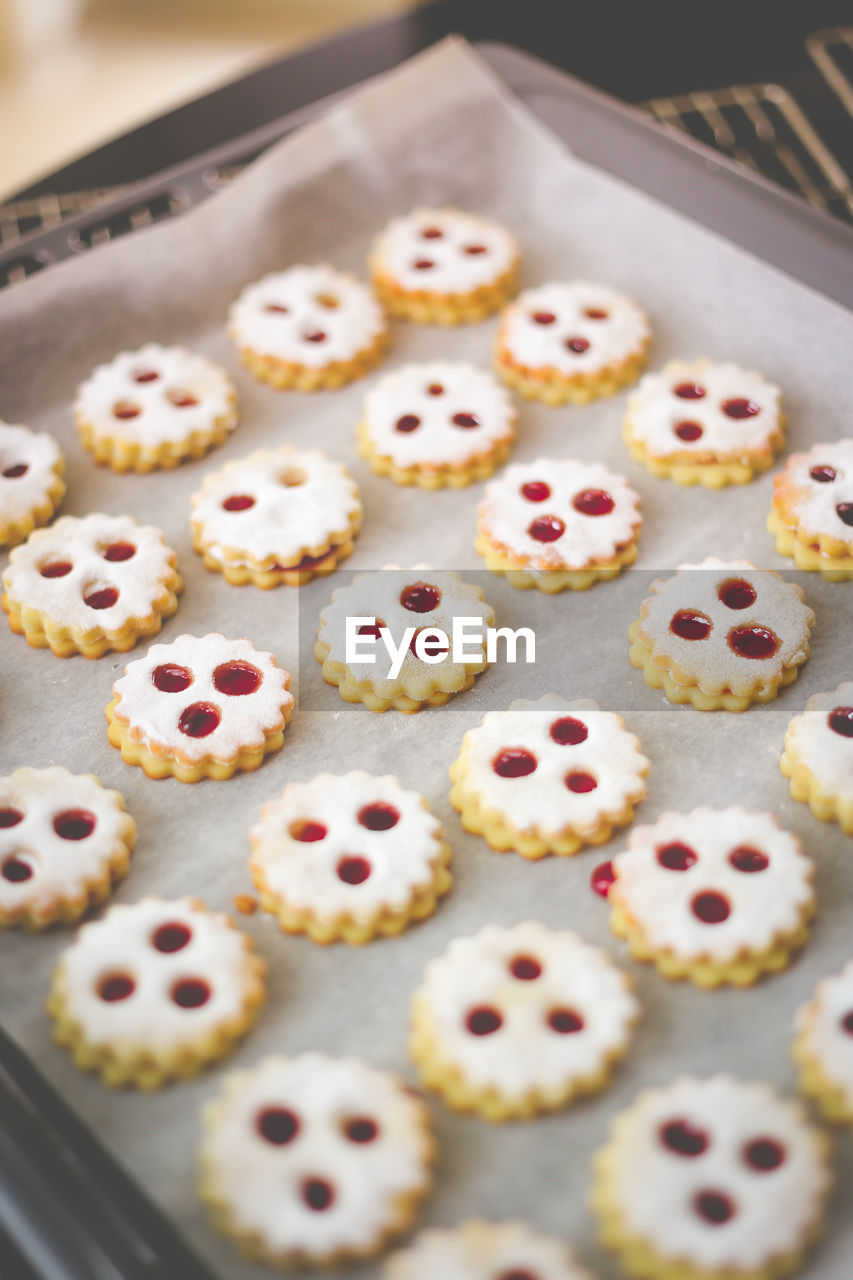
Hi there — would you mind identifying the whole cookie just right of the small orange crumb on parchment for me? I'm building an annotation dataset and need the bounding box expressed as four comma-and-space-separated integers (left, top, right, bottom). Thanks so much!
250, 769, 452, 942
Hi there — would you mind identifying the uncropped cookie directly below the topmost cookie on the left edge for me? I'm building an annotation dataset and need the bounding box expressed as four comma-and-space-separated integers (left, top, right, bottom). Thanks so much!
0, 513, 183, 658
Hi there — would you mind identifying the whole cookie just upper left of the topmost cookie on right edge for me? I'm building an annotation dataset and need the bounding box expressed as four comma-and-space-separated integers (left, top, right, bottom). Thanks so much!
625, 360, 785, 489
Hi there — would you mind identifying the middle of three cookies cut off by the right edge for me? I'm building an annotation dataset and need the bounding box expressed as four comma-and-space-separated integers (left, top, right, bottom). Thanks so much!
779, 680, 853, 836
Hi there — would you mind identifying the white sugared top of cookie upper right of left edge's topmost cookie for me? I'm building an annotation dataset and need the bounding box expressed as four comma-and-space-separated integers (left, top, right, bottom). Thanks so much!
74, 342, 237, 447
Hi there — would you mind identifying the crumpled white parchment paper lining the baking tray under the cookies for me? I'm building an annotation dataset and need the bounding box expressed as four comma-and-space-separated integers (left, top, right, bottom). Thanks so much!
0, 35, 853, 1280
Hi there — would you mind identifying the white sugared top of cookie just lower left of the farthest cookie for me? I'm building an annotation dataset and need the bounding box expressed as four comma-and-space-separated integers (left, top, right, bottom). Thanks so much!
228, 266, 386, 369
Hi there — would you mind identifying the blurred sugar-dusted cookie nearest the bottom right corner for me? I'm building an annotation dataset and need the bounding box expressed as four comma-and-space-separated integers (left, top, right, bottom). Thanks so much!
592, 1075, 831, 1280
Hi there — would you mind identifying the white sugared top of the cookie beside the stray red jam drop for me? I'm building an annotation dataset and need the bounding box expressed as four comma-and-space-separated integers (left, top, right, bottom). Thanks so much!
608, 806, 815, 964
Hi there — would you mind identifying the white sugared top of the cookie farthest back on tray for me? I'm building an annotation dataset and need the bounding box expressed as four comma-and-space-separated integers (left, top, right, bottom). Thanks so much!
370, 209, 519, 294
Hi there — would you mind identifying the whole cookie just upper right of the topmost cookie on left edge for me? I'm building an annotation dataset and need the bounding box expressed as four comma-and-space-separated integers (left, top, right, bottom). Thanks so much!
74, 342, 237, 471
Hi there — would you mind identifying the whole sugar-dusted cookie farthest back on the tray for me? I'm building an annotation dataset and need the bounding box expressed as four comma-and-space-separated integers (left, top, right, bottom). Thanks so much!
369, 209, 521, 325
